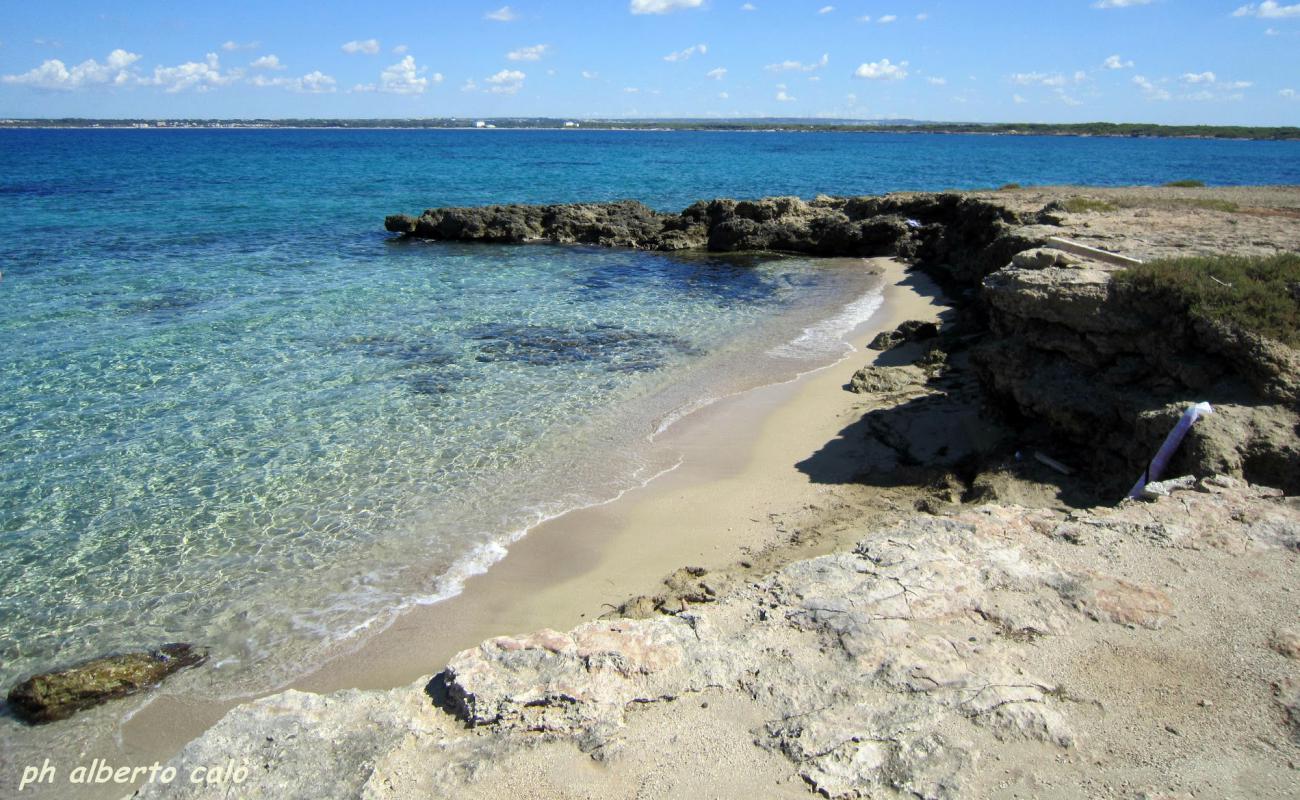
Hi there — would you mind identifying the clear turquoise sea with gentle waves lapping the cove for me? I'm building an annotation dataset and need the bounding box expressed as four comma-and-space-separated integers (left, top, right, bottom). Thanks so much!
0, 130, 1300, 736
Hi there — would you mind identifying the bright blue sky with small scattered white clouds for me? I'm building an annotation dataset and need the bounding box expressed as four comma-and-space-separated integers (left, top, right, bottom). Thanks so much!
0, 0, 1300, 125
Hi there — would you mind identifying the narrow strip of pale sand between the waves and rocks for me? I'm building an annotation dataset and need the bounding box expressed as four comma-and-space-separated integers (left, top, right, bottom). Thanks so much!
106, 259, 944, 764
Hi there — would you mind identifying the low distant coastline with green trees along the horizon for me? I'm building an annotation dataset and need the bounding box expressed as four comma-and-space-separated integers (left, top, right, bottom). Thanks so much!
0, 117, 1300, 140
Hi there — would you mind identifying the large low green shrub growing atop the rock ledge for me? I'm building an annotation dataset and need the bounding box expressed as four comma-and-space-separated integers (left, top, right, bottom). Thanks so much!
1117, 252, 1300, 347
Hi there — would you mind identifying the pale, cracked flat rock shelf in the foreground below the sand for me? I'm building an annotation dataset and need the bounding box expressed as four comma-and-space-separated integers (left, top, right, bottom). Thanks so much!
131, 477, 1300, 799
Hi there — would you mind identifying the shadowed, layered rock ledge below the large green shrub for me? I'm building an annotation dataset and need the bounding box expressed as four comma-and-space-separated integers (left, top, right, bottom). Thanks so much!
972, 250, 1300, 492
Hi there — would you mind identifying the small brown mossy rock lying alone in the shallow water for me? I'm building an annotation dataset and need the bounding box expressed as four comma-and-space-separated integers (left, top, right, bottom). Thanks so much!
7, 643, 208, 725
